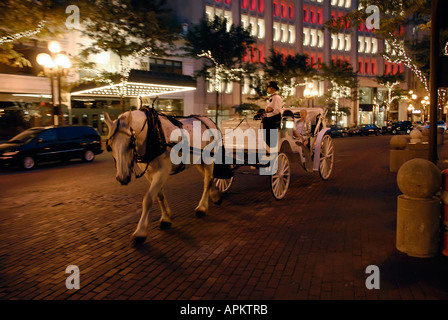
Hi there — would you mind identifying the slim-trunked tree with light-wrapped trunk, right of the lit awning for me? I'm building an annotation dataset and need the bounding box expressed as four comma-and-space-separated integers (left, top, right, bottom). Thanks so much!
184, 16, 256, 121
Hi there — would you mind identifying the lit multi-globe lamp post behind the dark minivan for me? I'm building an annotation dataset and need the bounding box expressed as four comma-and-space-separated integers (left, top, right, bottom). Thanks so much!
36, 41, 72, 126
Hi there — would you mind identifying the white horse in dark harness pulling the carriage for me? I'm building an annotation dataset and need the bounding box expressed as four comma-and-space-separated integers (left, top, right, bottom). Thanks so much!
103, 110, 222, 243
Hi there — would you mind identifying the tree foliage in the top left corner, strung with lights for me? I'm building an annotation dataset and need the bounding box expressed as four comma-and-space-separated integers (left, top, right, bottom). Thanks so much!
0, 0, 79, 68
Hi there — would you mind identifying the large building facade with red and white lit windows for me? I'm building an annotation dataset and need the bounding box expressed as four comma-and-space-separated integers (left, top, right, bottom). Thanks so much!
168, 0, 408, 126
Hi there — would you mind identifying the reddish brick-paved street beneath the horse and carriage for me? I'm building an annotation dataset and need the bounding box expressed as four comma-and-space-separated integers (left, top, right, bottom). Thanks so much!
0, 136, 448, 300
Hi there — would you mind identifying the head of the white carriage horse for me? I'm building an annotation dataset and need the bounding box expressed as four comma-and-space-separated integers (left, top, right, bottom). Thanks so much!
104, 111, 135, 185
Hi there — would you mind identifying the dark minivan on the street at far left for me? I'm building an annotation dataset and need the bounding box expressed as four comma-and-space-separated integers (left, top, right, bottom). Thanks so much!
0, 126, 103, 170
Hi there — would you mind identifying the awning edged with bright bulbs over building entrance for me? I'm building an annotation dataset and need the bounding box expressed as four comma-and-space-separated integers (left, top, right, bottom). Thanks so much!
71, 70, 196, 98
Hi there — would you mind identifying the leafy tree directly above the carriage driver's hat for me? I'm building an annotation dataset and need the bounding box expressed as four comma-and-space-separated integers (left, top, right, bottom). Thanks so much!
247, 49, 316, 101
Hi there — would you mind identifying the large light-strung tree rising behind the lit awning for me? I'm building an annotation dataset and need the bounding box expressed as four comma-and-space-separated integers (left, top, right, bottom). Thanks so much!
80, 0, 180, 111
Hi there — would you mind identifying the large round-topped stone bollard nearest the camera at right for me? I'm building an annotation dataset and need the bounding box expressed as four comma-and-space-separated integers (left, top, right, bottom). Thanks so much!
396, 159, 442, 258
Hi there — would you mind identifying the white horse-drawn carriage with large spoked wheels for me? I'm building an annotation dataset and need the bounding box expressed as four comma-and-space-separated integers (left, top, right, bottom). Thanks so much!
214, 107, 334, 200
